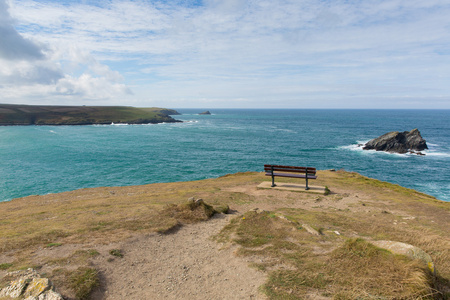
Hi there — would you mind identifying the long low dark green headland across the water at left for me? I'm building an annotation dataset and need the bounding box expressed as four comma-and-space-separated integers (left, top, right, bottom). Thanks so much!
0, 104, 181, 125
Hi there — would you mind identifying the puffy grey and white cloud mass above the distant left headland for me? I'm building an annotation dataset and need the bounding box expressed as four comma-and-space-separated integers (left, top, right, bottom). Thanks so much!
0, 0, 132, 103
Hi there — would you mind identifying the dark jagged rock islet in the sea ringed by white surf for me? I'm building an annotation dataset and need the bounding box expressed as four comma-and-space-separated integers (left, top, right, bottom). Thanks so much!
363, 128, 428, 154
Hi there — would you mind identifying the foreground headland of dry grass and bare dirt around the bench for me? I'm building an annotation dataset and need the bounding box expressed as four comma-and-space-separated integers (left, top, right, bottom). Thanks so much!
0, 170, 450, 299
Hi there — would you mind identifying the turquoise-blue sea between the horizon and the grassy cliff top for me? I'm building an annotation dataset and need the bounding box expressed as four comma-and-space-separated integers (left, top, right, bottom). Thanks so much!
0, 108, 450, 201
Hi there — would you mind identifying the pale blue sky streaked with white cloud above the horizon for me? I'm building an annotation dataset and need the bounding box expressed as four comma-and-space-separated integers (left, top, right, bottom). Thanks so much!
0, 0, 450, 109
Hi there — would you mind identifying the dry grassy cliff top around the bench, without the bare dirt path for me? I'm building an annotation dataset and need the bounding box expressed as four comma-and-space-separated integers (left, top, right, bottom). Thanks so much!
0, 171, 450, 299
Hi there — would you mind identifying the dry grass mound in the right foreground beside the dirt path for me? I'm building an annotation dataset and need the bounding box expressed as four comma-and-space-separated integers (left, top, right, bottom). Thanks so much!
218, 212, 448, 299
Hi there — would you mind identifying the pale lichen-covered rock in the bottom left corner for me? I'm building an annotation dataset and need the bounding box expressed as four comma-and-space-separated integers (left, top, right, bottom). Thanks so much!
0, 269, 63, 300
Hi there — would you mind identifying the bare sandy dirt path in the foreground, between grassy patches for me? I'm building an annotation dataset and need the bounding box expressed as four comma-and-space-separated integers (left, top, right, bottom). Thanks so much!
93, 215, 266, 300
